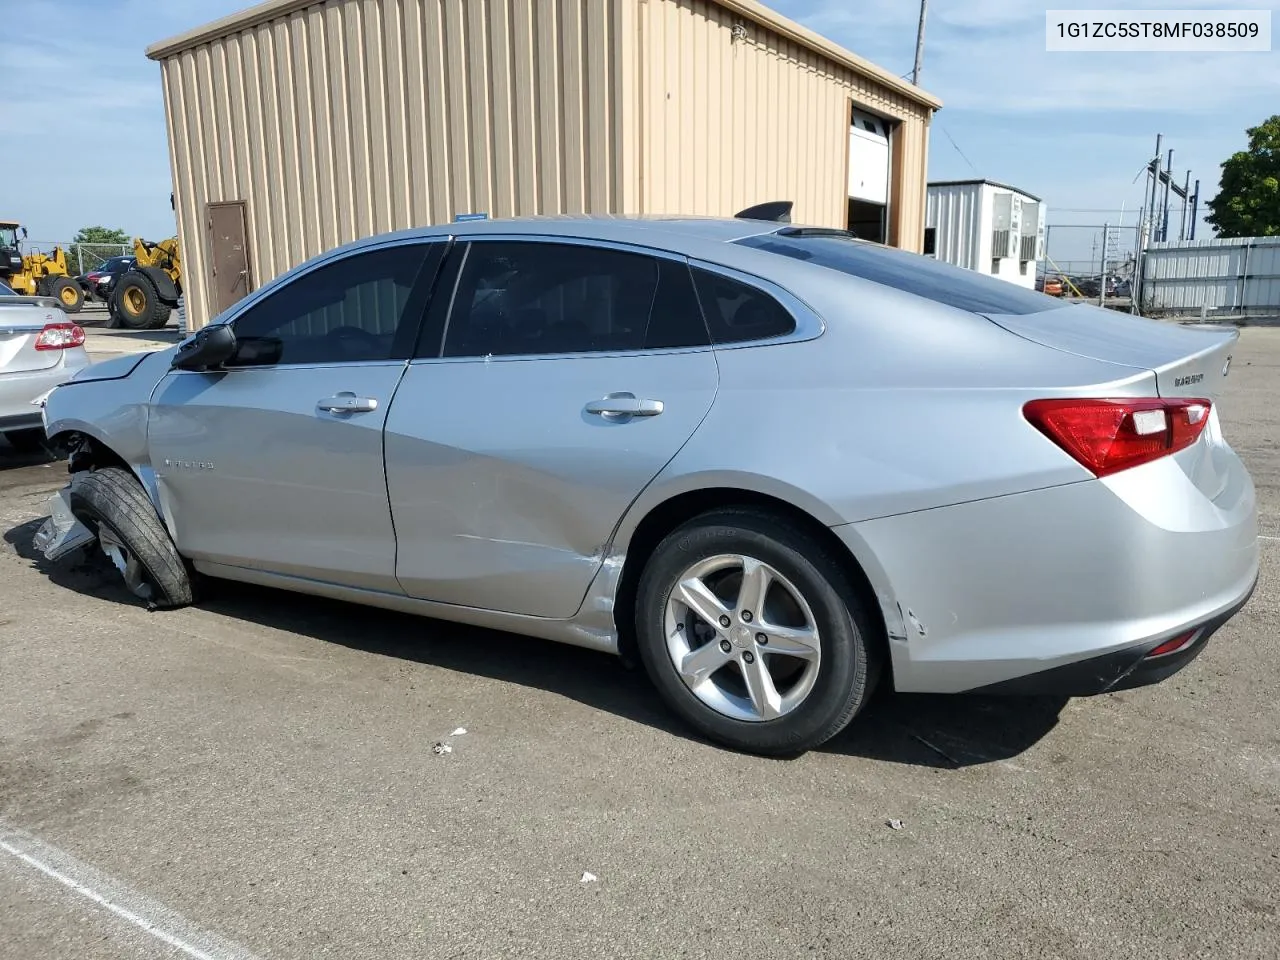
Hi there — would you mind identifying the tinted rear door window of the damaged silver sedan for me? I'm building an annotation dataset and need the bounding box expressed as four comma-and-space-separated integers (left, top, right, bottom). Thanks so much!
444, 241, 708, 357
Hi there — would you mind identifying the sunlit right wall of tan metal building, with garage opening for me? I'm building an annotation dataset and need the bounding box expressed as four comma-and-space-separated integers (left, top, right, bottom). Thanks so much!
625, 0, 927, 250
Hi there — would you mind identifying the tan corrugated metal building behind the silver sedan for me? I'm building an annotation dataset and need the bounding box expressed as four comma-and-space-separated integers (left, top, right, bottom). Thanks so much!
147, 0, 940, 328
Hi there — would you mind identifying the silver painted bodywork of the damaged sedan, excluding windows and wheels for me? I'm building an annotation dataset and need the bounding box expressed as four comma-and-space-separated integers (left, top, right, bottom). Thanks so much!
37, 218, 1257, 691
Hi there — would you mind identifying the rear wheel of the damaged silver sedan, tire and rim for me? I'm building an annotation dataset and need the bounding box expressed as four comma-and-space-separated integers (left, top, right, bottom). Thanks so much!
635, 508, 881, 755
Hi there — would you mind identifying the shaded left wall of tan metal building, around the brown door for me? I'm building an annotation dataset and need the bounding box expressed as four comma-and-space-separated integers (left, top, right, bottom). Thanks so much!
161, 0, 621, 329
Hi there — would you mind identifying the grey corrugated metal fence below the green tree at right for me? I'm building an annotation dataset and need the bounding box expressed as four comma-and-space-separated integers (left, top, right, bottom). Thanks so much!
1140, 237, 1280, 316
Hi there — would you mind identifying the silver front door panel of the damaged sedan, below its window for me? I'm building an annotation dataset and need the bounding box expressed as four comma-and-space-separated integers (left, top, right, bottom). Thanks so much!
147, 362, 404, 590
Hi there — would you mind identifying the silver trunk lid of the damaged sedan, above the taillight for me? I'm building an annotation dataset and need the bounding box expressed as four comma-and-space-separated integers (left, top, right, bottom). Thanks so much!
986, 303, 1240, 401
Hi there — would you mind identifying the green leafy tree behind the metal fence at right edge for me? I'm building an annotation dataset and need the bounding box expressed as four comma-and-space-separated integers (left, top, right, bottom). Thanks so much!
1204, 114, 1280, 238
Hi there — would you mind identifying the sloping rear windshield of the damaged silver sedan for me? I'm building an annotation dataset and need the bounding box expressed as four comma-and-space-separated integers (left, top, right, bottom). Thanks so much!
736, 230, 1066, 314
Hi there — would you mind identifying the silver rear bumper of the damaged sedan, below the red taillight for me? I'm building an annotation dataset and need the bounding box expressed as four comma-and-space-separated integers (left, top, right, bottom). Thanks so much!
833, 445, 1258, 695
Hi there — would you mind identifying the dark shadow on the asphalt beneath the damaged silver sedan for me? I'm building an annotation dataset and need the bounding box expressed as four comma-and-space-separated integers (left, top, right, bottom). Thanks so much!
5, 521, 1066, 769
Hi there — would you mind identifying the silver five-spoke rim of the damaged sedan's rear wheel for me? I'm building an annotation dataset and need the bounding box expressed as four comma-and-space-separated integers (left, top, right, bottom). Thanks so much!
663, 554, 822, 723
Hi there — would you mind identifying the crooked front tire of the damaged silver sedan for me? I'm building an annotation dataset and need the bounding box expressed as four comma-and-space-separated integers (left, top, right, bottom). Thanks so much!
70, 467, 193, 608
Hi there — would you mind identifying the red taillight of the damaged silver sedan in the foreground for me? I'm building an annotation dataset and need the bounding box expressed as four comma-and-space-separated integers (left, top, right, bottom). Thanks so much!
1023, 398, 1212, 476
